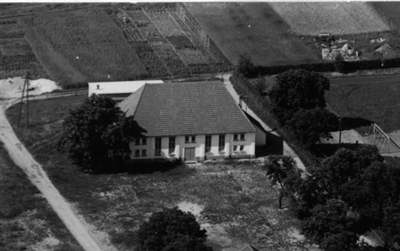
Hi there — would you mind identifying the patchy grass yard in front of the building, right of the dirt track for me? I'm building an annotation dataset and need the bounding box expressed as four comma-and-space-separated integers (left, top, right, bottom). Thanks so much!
7, 96, 298, 251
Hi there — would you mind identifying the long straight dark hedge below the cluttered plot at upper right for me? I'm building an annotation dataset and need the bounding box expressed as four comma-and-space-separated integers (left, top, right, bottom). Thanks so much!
257, 58, 400, 75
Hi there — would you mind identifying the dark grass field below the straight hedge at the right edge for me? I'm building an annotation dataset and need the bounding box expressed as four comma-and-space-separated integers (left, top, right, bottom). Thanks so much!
326, 75, 400, 133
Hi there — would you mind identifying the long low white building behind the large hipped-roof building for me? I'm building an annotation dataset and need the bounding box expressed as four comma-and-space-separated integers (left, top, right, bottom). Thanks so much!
88, 80, 164, 101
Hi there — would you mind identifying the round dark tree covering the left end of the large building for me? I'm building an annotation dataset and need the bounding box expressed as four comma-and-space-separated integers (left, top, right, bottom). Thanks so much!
58, 95, 145, 169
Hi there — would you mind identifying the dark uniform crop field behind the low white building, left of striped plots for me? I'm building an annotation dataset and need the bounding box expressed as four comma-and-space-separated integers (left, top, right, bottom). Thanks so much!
24, 8, 148, 84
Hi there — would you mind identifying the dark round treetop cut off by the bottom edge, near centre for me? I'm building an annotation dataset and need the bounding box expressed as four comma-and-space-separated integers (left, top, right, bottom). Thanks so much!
136, 207, 212, 251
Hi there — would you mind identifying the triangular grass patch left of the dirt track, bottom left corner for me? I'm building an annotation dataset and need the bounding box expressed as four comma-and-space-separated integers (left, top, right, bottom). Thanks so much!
0, 143, 83, 251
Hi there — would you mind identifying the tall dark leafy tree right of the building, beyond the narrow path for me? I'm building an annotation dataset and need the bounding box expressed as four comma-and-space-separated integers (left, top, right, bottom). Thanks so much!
268, 69, 337, 149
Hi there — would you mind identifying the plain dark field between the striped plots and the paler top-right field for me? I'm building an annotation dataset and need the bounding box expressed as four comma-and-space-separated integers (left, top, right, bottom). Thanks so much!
185, 3, 318, 66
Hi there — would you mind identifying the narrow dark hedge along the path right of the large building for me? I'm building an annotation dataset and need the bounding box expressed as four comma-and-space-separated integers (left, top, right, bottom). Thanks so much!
230, 72, 318, 167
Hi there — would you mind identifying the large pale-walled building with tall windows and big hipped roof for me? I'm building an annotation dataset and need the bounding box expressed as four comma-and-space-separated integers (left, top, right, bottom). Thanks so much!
119, 81, 257, 162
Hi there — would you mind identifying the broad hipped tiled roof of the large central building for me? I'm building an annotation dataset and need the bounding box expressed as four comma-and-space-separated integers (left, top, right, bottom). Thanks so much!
119, 81, 256, 136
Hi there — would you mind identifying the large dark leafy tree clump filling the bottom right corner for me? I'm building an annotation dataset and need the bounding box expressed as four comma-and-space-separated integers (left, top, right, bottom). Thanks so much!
296, 145, 400, 250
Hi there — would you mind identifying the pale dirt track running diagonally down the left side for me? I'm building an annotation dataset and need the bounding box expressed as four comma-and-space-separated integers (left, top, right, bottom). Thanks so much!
0, 101, 105, 251
